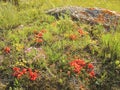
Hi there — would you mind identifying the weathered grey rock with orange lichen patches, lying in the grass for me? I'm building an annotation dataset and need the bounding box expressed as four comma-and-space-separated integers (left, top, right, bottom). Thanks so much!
46, 6, 120, 29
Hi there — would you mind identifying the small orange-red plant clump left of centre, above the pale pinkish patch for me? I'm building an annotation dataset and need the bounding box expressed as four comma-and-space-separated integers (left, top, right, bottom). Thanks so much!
34, 30, 46, 43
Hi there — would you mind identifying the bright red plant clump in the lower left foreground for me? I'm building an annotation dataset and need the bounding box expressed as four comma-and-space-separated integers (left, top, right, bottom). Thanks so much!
13, 67, 38, 81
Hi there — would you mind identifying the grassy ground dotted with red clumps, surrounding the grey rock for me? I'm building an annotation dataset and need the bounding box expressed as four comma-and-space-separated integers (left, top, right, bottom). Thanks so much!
0, 0, 120, 90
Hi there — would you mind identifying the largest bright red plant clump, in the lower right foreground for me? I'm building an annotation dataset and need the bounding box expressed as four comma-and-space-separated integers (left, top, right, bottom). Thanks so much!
70, 59, 95, 78
